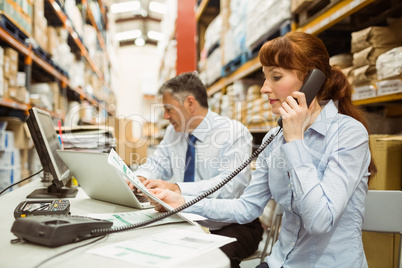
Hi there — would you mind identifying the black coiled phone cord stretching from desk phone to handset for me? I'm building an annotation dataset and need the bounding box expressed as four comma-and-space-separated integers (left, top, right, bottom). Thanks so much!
91, 127, 282, 236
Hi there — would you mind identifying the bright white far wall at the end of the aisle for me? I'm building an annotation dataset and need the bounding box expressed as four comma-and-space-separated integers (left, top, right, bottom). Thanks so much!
114, 45, 160, 137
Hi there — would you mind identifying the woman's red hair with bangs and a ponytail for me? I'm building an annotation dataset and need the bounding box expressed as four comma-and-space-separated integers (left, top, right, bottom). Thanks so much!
259, 32, 376, 180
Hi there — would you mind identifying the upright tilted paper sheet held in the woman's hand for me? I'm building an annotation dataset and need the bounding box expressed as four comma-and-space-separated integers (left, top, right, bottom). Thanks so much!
108, 149, 198, 225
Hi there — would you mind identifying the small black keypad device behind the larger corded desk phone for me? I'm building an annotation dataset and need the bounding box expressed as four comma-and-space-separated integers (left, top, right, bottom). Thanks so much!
14, 199, 70, 219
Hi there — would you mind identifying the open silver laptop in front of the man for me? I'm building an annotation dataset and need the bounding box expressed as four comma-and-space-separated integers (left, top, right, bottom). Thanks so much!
57, 150, 152, 209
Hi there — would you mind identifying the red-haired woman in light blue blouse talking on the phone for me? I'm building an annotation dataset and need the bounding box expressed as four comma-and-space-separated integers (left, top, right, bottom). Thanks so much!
152, 32, 375, 268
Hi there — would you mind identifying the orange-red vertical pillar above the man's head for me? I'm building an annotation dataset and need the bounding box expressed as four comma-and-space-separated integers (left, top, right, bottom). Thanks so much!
176, 0, 197, 74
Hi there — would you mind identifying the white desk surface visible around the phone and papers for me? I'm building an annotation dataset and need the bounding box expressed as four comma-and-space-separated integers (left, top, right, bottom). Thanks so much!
0, 178, 230, 268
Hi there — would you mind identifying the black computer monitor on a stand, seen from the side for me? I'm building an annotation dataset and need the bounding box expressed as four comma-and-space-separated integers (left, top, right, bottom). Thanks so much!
27, 108, 77, 198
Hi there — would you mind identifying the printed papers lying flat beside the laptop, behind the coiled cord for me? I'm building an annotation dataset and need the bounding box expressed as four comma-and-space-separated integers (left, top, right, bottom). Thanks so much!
86, 208, 205, 228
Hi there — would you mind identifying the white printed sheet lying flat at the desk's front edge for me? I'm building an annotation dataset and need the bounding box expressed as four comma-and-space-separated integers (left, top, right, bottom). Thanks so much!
87, 229, 236, 268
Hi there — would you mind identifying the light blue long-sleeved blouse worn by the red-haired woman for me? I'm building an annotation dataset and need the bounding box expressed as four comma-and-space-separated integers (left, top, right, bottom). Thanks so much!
185, 101, 371, 268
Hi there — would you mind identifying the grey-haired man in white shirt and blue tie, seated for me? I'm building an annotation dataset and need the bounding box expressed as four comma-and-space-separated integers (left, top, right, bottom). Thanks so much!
131, 73, 263, 267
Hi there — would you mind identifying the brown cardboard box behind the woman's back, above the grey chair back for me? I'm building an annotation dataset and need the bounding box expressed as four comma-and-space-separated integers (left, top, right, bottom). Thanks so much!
369, 135, 402, 190
